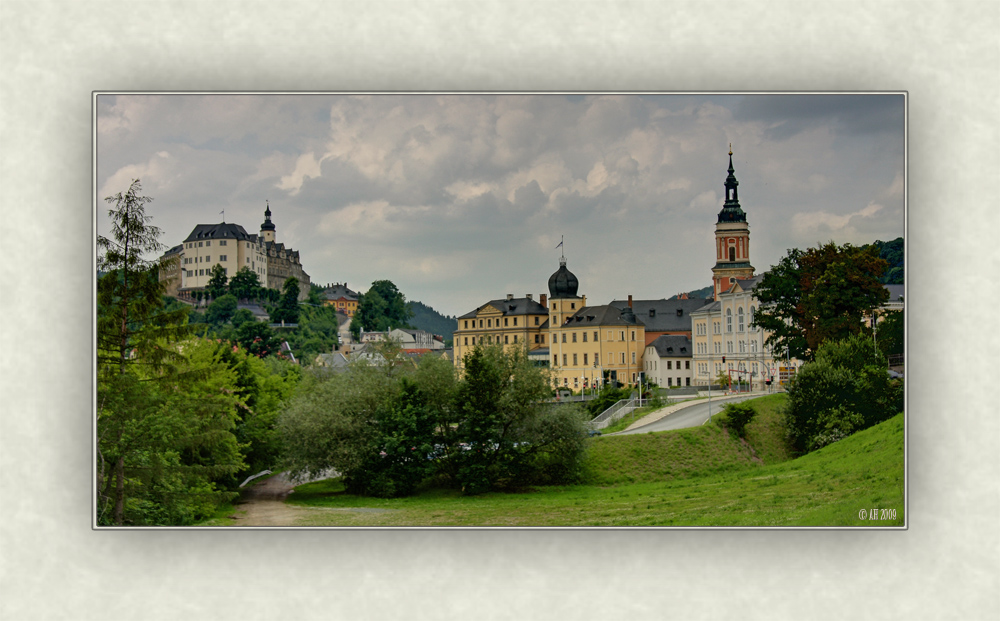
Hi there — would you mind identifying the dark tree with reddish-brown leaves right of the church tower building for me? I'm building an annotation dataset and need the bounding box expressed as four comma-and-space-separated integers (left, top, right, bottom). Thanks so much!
753, 242, 888, 359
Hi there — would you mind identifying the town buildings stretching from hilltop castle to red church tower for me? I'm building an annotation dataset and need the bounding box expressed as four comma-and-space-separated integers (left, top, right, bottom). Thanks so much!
160, 148, 904, 392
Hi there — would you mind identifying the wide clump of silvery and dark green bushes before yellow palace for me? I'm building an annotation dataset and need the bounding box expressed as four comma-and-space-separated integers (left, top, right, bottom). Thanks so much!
279, 342, 585, 496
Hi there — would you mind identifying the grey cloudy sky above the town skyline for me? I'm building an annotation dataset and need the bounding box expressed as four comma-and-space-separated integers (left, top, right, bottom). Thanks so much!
96, 94, 905, 315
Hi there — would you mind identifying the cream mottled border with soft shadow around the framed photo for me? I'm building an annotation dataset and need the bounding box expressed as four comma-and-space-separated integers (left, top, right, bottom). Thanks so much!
0, 0, 1000, 619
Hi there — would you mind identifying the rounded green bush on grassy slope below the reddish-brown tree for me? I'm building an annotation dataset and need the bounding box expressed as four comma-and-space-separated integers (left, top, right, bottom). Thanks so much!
786, 335, 903, 452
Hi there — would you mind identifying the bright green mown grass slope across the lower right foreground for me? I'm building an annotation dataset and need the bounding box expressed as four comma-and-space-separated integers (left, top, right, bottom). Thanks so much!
278, 397, 904, 526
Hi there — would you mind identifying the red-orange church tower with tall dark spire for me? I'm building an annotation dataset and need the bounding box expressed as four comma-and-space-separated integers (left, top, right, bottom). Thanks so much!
712, 144, 753, 300
